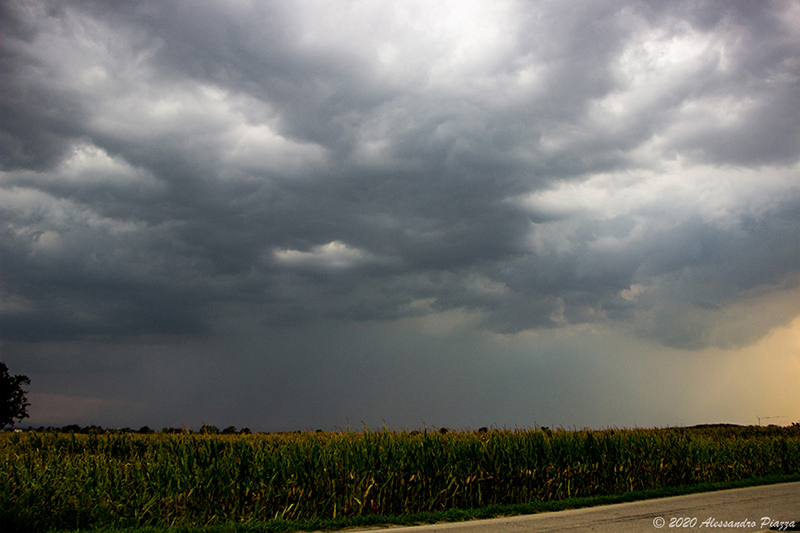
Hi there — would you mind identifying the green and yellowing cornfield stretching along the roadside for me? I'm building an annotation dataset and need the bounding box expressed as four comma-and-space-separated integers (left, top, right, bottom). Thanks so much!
0, 428, 800, 530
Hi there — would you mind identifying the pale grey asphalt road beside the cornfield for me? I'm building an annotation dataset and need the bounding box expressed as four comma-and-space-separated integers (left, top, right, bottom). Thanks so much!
351, 482, 800, 533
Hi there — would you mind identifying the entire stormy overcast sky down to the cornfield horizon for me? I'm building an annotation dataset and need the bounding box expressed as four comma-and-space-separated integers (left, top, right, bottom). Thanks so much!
0, 0, 800, 431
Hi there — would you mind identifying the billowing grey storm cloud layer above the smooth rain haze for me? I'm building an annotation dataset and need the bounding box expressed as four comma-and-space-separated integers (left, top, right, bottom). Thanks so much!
0, 1, 800, 360
